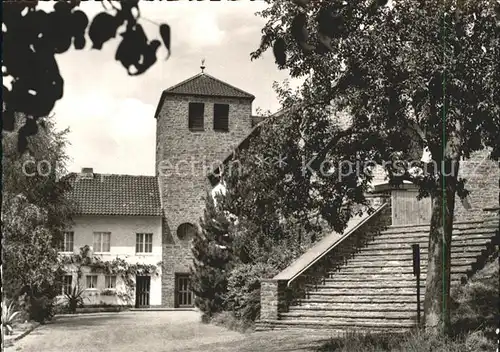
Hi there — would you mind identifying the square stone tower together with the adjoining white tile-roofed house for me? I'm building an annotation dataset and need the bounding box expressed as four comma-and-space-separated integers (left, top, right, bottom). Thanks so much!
65, 66, 259, 308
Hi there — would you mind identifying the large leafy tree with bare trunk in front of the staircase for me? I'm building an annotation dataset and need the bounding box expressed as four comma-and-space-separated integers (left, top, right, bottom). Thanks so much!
252, 0, 500, 333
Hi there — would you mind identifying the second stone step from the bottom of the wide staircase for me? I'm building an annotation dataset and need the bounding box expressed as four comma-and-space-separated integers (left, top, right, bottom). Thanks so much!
280, 308, 417, 321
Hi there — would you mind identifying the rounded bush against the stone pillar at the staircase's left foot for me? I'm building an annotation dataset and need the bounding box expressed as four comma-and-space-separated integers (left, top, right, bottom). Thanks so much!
226, 263, 277, 321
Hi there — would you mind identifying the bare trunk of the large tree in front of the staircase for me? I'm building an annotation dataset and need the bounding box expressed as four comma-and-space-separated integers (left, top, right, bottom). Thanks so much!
424, 161, 458, 334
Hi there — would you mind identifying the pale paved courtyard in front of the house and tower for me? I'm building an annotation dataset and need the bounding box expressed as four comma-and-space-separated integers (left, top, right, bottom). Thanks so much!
5, 311, 334, 352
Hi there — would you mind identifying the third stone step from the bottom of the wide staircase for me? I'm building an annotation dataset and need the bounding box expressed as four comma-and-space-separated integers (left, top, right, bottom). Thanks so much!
289, 300, 416, 312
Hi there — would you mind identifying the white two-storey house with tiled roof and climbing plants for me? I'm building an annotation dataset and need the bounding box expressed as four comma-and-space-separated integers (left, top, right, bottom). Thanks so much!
59, 168, 163, 307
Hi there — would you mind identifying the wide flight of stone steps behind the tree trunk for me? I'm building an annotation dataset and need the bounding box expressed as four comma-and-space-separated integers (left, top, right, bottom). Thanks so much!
257, 214, 500, 331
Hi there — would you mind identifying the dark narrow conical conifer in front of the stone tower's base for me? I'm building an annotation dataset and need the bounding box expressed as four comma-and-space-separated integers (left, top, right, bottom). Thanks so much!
191, 195, 234, 321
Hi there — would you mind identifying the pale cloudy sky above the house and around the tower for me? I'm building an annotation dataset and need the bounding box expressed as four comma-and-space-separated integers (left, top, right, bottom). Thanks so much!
41, 1, 295, 175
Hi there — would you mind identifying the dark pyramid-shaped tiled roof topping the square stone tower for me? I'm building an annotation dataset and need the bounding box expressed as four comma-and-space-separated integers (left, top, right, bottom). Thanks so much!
155, 72, 255, 118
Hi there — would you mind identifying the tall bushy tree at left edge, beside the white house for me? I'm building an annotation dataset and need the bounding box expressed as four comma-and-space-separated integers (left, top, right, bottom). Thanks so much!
2, 114, 72, 321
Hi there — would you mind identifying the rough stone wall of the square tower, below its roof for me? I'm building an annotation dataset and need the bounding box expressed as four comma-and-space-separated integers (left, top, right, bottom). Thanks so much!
156, 96, 252, 307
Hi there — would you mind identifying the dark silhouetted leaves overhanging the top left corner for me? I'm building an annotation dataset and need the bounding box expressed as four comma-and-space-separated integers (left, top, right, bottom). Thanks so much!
2, 0, 170, 152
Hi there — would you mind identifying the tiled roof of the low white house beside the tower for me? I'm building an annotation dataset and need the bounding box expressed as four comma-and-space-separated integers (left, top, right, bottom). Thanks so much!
68, 173, 162, 216
